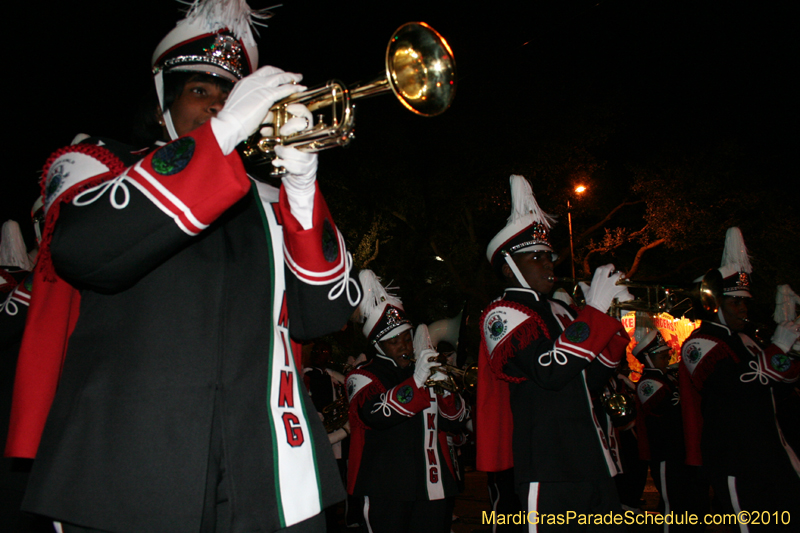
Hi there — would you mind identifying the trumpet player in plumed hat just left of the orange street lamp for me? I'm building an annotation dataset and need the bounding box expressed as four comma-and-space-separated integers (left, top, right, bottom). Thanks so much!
476, 176, 632, 531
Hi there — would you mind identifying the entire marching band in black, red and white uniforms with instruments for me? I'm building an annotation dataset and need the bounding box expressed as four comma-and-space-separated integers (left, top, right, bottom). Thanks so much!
0, 0, 800, 533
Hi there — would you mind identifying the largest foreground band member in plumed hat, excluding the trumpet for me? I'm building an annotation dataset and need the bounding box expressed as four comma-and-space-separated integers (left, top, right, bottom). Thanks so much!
6, 0, 360, 533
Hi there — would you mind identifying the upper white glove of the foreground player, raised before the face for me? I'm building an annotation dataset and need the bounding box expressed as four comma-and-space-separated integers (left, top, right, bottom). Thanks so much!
211, 67, 305, 155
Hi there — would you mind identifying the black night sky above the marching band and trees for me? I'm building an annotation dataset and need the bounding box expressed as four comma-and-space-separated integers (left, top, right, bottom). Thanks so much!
0, 0, 797, 247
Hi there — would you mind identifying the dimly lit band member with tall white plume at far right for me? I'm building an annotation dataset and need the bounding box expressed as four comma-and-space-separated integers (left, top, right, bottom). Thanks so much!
679, 227, 800, 531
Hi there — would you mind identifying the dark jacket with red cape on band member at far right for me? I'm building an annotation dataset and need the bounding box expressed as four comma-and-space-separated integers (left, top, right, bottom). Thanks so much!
679, 320, 800, 478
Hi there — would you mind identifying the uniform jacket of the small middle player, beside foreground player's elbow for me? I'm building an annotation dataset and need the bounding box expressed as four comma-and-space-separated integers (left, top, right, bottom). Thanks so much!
347, 354, 468, 501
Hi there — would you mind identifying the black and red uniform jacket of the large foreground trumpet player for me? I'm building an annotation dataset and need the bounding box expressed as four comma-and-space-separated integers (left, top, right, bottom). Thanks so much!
7, 123, 359, 533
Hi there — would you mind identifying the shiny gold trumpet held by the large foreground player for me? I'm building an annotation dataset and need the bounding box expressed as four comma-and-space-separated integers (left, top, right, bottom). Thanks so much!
242, 22, 456, 171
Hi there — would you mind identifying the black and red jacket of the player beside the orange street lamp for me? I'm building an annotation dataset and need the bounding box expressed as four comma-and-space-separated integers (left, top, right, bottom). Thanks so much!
476, 288, 629, 486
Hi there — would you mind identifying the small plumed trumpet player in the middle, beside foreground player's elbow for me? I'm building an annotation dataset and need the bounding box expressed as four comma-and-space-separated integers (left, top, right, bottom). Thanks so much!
347, 270, 467, 533
